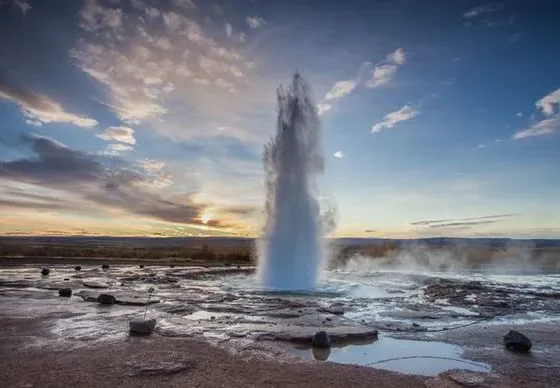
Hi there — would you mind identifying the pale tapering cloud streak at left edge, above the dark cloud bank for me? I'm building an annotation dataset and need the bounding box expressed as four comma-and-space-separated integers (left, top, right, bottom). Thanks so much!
0, 80, 98, 128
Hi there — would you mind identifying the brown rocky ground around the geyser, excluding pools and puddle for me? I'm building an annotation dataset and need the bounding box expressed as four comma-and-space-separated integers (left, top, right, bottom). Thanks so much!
0, 267, 560, 387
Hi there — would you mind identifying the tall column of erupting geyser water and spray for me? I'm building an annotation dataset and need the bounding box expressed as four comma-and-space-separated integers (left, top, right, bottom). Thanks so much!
258, 73, 324, 290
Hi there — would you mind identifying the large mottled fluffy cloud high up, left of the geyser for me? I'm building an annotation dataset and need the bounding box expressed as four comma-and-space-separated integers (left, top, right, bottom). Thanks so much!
71, 1, 255, 131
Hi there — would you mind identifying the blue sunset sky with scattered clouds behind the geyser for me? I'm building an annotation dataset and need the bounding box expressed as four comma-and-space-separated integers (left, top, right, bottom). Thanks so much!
0, 0, 560, 238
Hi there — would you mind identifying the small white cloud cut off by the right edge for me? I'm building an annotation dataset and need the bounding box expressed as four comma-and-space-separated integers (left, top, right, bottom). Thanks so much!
513, 89, 560, 140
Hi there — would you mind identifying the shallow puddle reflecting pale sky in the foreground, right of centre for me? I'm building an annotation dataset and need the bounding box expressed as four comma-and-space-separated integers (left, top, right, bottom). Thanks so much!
293, 337, 490, 376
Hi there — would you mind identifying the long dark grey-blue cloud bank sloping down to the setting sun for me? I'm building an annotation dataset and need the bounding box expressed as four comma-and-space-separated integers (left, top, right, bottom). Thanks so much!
0, 136, 224, 227
